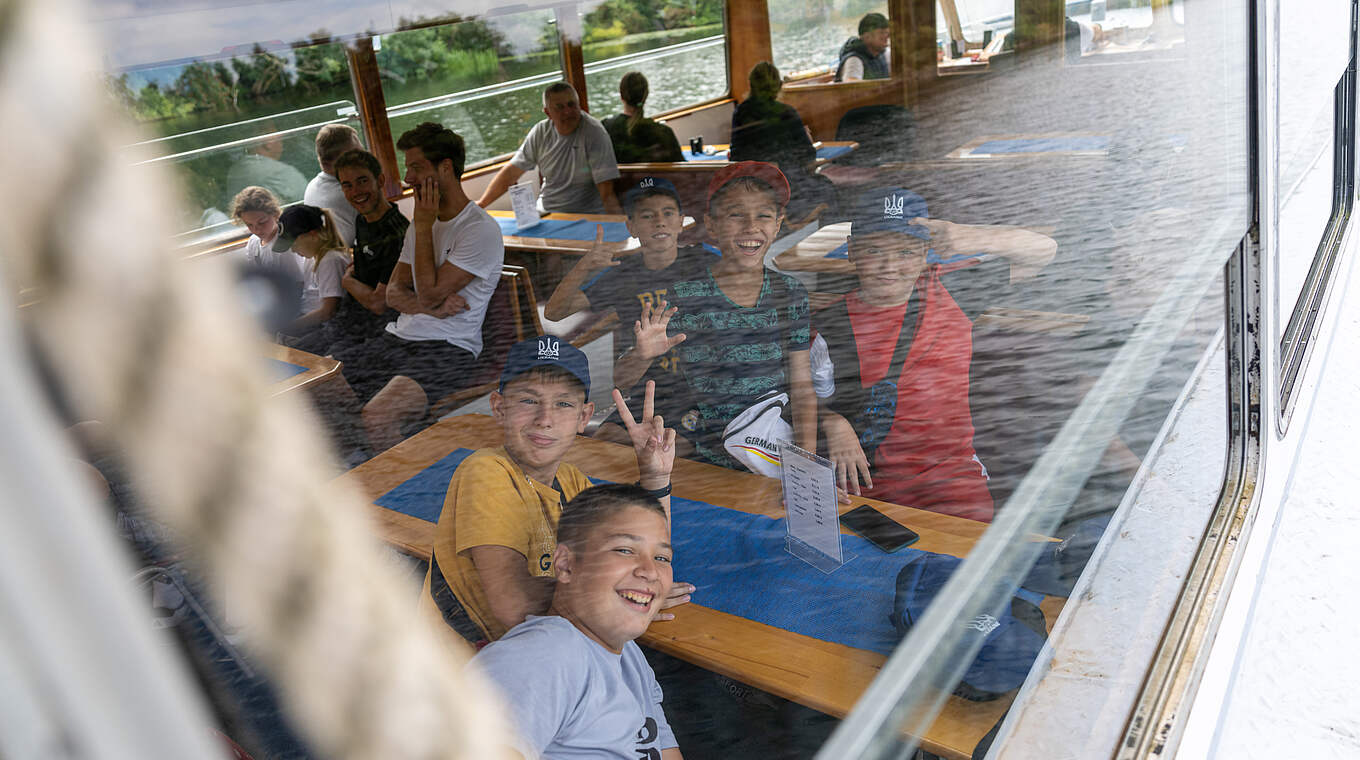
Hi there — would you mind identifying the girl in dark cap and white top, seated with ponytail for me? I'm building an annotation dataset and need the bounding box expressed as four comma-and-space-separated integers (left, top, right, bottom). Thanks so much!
273, 204, 350, 336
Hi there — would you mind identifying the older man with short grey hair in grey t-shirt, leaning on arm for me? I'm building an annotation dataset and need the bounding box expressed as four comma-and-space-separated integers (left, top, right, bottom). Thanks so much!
477, 82, 619, 213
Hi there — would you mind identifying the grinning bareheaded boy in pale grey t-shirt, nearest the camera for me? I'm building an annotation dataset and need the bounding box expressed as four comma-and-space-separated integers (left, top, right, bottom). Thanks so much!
472, 484, 680, 760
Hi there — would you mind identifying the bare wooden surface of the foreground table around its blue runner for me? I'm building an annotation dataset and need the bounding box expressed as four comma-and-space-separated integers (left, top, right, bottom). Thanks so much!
339, 415, 1061, 760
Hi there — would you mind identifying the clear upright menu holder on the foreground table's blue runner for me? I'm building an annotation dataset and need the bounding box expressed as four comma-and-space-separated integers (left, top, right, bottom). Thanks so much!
779, 441, 854, 574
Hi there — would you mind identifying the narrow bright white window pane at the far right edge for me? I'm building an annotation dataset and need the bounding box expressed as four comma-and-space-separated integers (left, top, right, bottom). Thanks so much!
1274, 3, 1350, 348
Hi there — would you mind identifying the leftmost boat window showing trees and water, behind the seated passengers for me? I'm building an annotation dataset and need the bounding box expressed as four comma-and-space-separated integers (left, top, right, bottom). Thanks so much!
105, 42, 362, 245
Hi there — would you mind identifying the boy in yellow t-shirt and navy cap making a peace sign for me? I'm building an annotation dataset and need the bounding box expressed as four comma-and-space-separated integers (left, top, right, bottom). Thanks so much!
420, 336, 692, 642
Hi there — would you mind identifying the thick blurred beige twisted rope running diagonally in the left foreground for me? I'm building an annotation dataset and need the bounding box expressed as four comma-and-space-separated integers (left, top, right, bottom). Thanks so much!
0, 0, 502, 760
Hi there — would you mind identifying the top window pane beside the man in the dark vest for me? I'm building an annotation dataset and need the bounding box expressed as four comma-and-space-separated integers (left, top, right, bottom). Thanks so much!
772, 0, 892, 80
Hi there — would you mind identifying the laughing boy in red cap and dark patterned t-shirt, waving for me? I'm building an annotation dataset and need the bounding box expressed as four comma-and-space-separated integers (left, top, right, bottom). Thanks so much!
660, 160, 817, 469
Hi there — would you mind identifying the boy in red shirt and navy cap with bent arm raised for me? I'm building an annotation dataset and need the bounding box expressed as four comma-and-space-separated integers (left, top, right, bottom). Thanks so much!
813, 189, 1058, 521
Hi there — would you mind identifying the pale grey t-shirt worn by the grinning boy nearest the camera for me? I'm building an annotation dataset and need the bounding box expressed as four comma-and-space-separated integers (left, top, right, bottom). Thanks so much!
472, 615, 679, 760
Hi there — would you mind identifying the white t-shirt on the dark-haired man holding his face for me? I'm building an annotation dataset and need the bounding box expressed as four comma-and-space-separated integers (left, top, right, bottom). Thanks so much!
388, 201, 506, 355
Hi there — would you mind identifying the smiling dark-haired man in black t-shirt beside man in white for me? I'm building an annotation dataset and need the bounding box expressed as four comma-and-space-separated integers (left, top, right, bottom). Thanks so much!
298, 150, 411, 353
